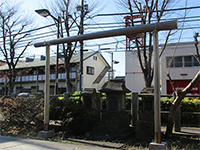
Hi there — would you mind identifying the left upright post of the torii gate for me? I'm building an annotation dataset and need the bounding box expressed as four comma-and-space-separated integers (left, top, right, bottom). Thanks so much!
44, 45, 50, 131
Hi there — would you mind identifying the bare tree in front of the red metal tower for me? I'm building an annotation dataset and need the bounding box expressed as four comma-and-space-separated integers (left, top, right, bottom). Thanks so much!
118, 0, 171, 87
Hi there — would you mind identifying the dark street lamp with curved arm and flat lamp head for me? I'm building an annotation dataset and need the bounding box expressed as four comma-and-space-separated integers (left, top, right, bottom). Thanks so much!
35, 9, 61, 95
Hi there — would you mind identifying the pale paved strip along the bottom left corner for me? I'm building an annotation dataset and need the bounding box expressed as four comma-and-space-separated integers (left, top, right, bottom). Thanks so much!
0, 136, 120, 150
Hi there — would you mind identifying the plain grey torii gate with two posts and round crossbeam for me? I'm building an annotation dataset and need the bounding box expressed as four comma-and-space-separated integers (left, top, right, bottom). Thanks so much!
34, 20, 178, 143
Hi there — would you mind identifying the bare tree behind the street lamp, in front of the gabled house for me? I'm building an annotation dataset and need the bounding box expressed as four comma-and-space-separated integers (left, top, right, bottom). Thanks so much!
44, 0, 101, 93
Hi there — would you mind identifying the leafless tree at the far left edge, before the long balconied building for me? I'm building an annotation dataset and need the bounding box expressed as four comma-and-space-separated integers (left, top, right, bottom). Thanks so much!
0, 2, 31, 94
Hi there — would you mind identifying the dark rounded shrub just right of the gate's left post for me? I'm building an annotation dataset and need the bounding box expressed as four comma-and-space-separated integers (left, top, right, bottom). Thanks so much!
50, 97, 95, 135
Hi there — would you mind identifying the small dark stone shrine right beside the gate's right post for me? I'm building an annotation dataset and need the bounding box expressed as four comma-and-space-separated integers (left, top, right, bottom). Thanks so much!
135, 87, 154, 139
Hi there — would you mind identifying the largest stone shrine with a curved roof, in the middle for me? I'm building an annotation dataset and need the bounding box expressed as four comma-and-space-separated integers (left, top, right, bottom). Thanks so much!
91, 80, 131, 140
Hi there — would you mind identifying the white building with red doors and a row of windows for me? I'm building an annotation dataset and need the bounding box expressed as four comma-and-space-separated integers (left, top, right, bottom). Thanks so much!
125, 42, 200, 95
